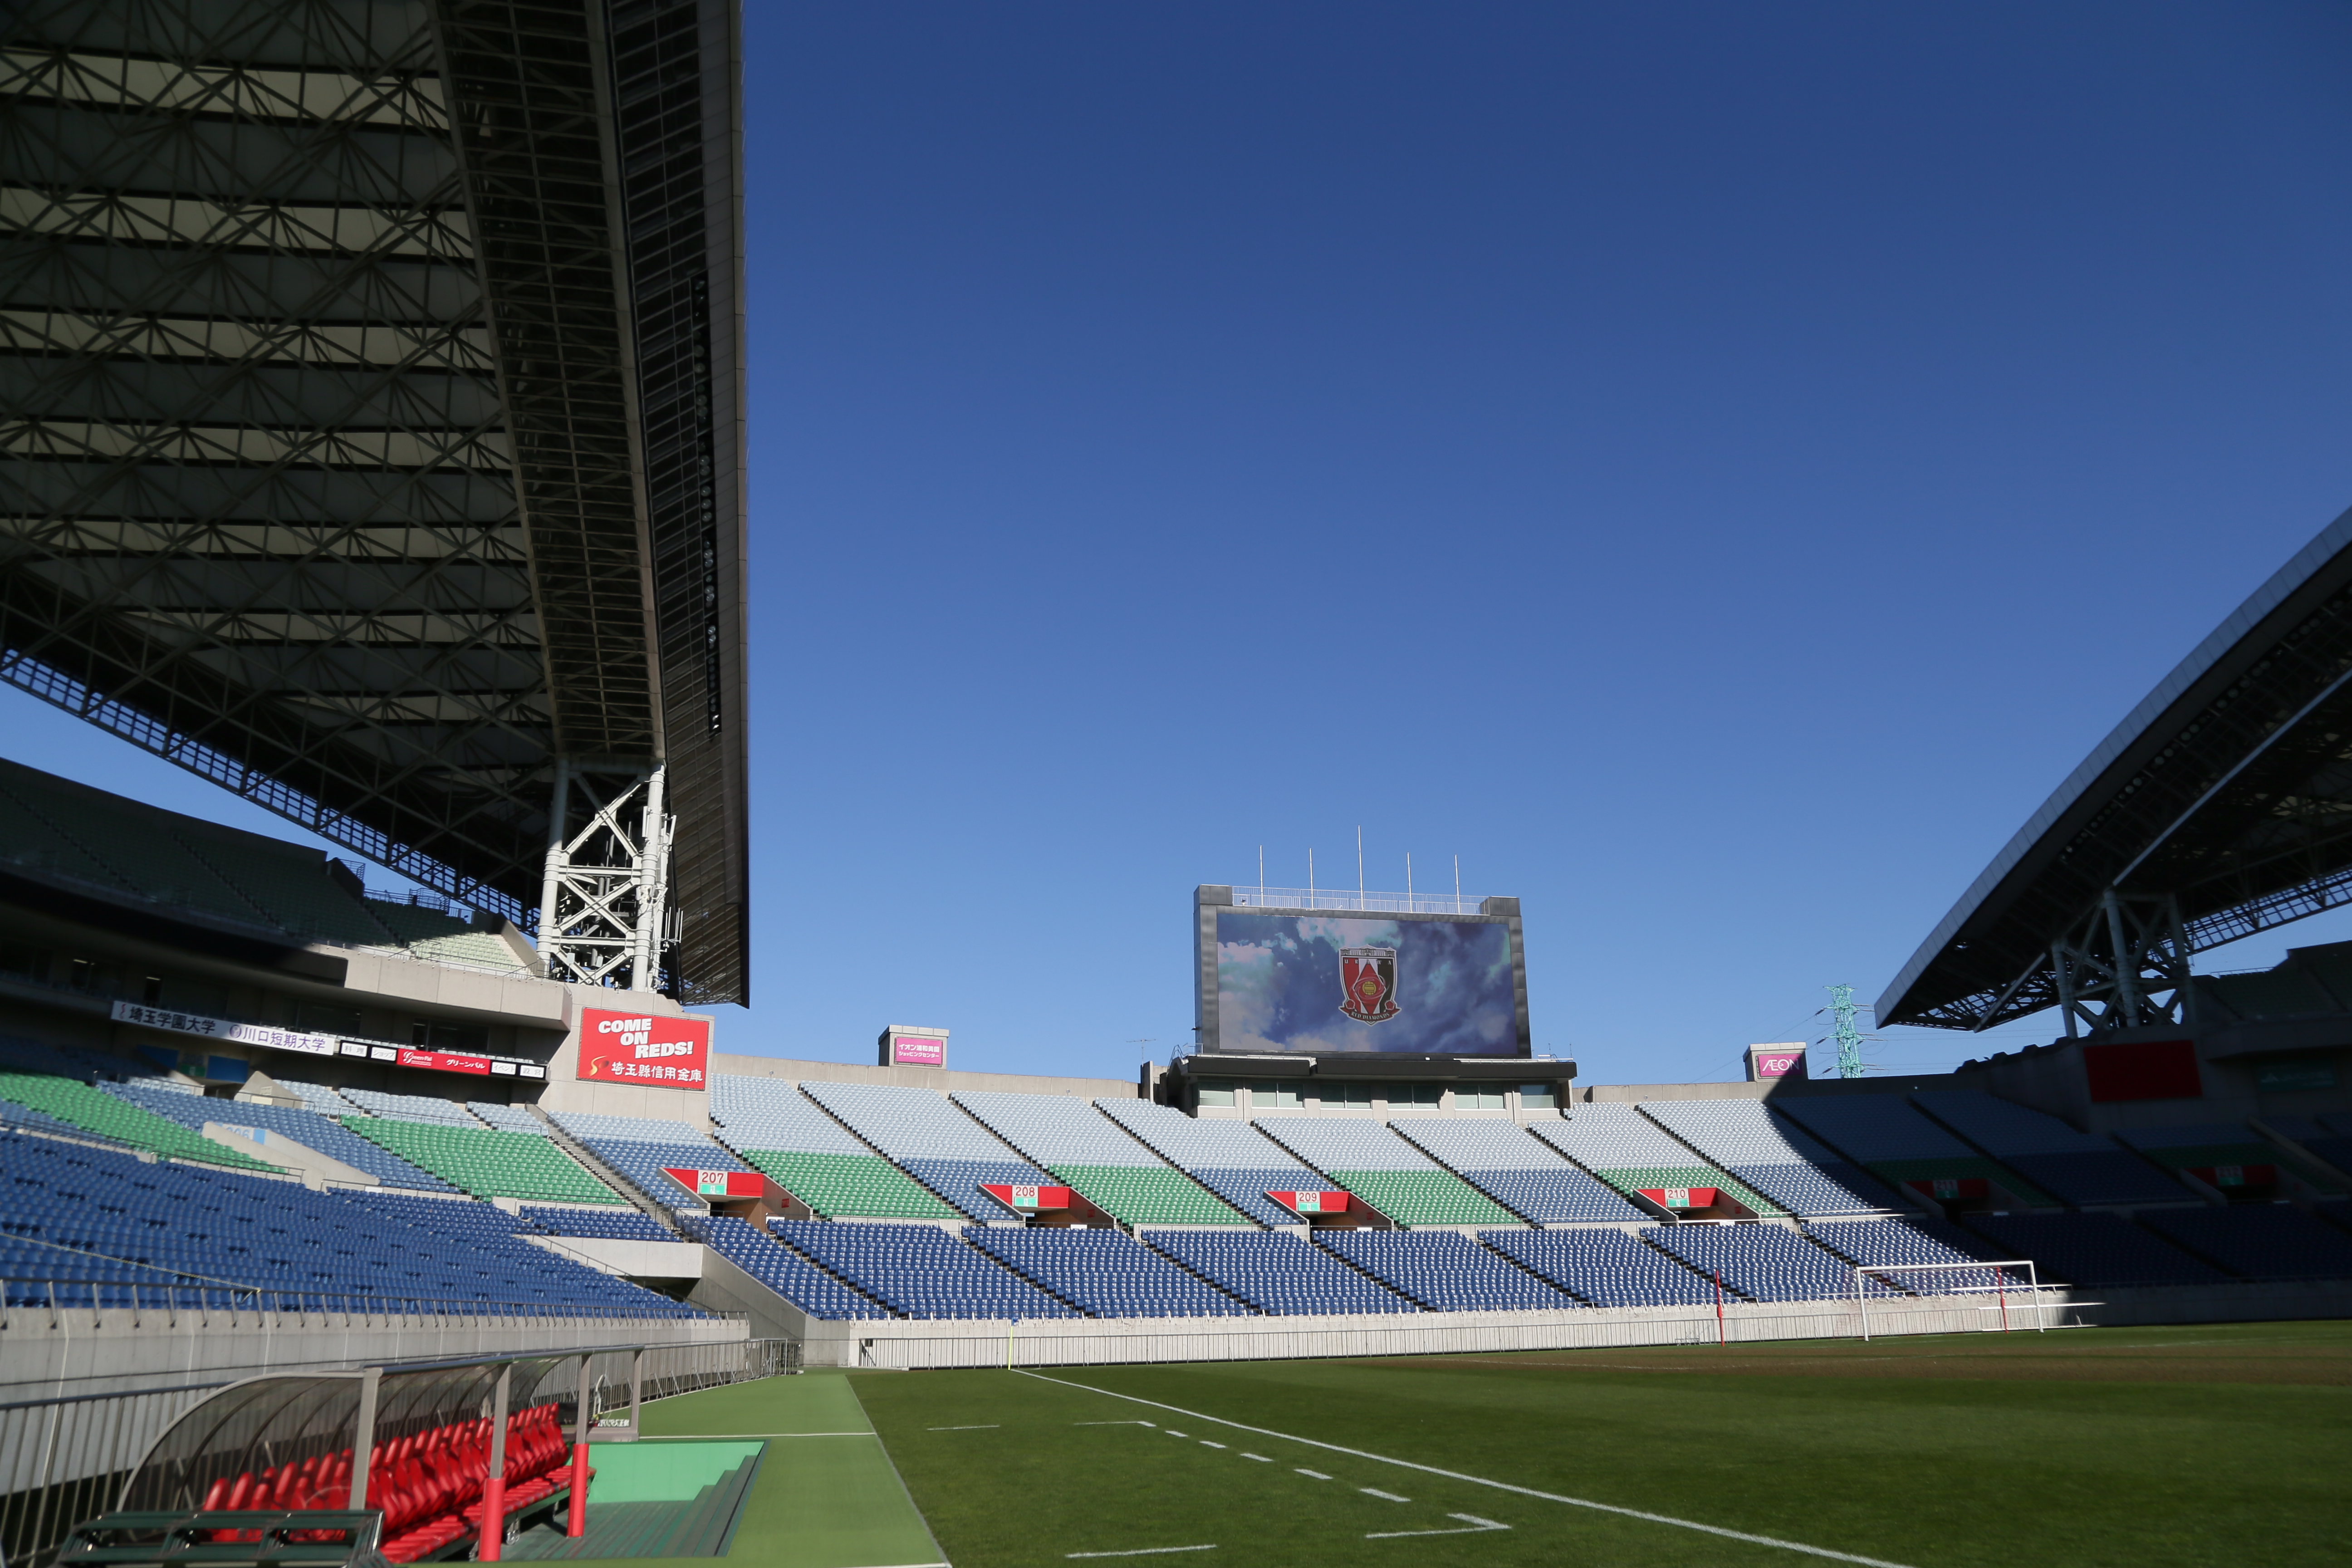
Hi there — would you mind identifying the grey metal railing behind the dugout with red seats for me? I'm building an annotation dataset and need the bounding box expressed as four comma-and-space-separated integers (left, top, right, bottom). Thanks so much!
0, 1340, 800, 1563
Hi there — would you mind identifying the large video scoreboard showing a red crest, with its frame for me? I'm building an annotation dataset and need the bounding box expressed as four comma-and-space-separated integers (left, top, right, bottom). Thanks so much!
1192, 886, 1531, 1055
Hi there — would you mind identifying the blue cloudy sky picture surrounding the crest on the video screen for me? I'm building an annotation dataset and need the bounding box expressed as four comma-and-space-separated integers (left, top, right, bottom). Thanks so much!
1216, 910, 1519, 1055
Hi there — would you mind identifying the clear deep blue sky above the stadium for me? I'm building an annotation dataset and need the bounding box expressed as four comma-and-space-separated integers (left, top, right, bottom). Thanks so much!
0, 0, 2352, 1081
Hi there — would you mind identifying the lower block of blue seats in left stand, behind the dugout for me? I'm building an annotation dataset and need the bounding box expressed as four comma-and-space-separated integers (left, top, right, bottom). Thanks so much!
0, 1133, 699, 1317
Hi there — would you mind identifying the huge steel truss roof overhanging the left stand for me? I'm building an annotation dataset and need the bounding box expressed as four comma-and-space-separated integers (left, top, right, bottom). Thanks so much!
0, 0, 748, 1001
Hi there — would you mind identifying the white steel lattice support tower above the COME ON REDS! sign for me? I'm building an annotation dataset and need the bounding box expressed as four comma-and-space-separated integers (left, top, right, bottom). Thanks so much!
539, 757, 677, 992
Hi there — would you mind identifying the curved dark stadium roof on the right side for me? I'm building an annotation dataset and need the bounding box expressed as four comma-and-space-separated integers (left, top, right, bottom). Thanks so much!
1877, 513, 2352, 1029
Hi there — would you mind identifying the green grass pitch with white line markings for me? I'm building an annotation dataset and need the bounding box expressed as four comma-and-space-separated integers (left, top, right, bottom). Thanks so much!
847, 1323, 2352, 1568
